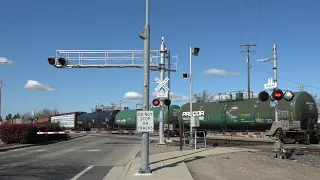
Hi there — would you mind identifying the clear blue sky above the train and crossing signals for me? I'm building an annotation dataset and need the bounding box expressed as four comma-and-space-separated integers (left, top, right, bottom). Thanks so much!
0, 0, 320, 116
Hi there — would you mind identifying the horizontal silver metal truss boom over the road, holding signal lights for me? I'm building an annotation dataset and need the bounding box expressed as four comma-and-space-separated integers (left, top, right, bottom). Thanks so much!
55, 50, 178, 72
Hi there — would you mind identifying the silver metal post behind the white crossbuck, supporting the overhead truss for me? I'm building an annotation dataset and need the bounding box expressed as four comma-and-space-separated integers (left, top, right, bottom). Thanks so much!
159, 37, 166, 145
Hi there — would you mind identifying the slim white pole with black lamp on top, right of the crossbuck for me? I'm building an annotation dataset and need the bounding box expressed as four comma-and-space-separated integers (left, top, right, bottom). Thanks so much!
182, 46, 200, 148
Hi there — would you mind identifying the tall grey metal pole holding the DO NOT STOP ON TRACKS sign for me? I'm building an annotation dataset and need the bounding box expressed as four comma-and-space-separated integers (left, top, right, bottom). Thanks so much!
139, 0, 151, 173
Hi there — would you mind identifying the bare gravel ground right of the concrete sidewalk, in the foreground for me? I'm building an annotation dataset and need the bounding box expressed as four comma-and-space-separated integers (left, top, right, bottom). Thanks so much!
186, 152, 320, 180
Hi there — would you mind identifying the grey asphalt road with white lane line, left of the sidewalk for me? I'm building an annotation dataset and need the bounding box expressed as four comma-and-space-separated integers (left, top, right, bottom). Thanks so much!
0, 135, 141, 180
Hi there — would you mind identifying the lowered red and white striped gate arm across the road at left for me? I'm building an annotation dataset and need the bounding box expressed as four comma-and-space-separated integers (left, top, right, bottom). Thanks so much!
37, 130, 135, 134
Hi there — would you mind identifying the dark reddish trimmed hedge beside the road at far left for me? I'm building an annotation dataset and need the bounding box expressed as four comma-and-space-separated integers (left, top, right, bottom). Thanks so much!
0, 124, 69, 144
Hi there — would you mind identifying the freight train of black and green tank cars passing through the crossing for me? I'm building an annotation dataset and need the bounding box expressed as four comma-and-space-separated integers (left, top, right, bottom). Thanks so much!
48, 91, 320, 144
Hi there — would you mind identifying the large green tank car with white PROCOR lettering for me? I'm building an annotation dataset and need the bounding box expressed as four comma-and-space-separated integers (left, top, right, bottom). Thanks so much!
178, 91, 319, 144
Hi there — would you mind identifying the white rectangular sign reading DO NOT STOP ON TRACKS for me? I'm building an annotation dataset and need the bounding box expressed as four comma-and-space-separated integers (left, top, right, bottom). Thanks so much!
136, 111, 154, 132
